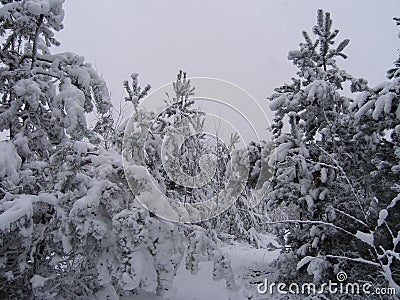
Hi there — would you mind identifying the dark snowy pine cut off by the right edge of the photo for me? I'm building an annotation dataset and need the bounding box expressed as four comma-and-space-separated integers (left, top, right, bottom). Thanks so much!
342, 18, 400, 293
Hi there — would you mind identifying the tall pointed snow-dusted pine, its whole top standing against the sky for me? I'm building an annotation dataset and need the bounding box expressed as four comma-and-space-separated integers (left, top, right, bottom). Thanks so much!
268, 10, 366, 286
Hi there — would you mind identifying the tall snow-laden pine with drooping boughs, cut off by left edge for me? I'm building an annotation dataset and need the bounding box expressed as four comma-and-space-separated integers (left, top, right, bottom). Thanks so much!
0, 1, 111, 298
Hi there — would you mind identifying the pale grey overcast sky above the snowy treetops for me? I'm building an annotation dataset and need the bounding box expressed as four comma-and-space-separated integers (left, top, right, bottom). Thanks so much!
53, 0, 400, 141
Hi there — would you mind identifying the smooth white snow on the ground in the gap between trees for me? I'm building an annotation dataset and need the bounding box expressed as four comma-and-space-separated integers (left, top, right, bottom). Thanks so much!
124, 235, 279, 300
